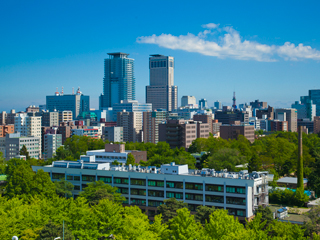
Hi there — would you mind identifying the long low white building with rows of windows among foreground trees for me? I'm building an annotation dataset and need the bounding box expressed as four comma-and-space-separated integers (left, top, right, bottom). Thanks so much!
32, 160, 269, 220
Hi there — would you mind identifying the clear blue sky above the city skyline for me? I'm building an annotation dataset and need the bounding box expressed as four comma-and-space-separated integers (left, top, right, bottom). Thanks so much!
0, 0, 320, 111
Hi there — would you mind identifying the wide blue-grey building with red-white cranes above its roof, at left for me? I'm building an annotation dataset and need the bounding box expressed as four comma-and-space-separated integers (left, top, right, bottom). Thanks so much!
46, 88, 90, 119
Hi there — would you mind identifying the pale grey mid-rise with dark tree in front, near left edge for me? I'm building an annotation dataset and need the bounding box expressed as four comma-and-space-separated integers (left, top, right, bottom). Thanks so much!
5, 133, 41, 160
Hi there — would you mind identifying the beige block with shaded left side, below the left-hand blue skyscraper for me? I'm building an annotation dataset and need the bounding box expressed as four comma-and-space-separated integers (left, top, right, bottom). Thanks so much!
117, 110, 142, 142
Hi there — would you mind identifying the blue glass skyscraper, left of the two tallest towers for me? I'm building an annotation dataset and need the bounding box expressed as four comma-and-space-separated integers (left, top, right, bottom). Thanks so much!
99, 52, 136, 110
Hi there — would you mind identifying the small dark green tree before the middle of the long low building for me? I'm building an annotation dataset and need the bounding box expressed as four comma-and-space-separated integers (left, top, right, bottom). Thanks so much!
158, 198, 188, 223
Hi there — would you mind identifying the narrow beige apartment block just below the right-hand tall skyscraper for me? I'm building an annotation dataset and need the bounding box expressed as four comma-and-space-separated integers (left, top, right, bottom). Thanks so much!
143, 110, 167, 144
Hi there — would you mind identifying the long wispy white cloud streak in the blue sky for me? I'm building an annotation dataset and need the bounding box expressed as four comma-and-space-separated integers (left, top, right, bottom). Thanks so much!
137, 23, 320, 62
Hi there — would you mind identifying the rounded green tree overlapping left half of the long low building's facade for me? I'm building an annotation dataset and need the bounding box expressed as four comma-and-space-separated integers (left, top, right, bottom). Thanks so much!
80, 181, 126, 205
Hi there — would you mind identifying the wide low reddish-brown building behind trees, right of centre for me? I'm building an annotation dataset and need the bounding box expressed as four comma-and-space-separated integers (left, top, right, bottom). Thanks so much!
220, 124, 254, 143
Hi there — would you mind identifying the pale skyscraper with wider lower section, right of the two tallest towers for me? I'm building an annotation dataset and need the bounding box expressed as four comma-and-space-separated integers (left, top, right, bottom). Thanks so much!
146, 54, 178, 111
